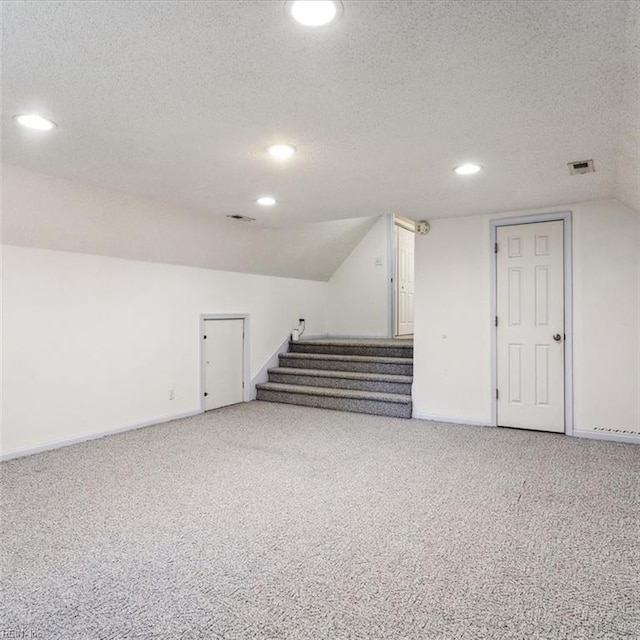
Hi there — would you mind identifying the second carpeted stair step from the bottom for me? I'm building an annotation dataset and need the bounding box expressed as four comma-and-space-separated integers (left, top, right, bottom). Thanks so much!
269, 367, 413, 395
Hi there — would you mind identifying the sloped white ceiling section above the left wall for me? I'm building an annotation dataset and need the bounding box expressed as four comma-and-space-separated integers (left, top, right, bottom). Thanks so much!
2, 165, 378, 281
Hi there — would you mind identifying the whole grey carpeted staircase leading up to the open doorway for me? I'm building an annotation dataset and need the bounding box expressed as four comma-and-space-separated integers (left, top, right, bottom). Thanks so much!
256, 338, 413, 418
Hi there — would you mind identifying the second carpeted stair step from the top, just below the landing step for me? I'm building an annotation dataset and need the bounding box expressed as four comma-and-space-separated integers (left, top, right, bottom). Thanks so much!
280, 352, 413, 376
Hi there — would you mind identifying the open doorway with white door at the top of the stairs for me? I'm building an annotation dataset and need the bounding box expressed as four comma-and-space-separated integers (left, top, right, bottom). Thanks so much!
393, 215, 415, 338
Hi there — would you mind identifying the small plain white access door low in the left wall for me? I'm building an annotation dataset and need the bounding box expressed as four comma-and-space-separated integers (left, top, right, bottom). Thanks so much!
204, 319, 244, 411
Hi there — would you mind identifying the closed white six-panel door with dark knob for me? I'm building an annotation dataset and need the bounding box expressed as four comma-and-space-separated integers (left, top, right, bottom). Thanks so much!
497, 221, 565, 433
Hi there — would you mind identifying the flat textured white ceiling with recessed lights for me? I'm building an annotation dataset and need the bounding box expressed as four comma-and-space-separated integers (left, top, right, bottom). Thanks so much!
2, 0, 640, 226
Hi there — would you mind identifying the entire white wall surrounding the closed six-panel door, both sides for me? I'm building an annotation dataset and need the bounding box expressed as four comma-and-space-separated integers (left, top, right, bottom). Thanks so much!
414, 201, 640, 440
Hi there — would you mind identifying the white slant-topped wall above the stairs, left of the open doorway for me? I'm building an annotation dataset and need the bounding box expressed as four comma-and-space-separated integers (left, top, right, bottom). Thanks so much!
329, 216, 390, 338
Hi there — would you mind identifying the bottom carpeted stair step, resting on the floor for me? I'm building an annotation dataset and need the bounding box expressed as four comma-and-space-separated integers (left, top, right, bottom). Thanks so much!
256, 382, 412, 418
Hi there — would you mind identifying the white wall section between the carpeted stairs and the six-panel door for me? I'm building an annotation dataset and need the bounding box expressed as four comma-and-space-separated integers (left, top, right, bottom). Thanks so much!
413, 216, 491, 423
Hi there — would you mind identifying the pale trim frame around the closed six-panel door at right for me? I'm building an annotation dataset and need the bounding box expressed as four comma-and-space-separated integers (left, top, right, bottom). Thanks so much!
490, 211, 573, 436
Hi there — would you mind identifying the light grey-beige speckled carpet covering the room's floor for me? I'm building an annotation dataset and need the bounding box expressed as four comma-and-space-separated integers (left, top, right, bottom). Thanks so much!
0, 402, 640, 640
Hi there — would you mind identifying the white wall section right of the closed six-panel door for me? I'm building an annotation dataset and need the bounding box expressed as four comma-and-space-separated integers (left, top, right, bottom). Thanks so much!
573, 203, 640, 433
